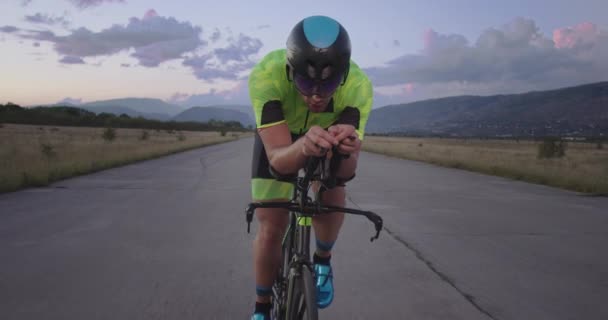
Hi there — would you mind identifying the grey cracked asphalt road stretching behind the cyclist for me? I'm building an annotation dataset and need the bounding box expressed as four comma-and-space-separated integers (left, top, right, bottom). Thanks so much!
0, 139, 608, 320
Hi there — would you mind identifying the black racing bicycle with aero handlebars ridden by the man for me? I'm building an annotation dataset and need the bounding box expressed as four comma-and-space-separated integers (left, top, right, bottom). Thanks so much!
245, 147, 383, 320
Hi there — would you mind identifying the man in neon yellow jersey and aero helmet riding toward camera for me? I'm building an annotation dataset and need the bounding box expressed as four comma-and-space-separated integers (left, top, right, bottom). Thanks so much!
249, 16, 373, 320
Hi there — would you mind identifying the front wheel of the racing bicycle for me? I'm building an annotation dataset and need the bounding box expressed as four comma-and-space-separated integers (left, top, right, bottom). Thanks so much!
287, 265, 319, 320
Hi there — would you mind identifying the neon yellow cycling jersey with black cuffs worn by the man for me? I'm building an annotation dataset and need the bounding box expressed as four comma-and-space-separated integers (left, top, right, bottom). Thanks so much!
249, 49, 373, 139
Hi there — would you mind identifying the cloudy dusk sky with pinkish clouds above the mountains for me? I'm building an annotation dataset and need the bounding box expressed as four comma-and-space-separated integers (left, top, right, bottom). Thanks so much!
0, 0, 608, 107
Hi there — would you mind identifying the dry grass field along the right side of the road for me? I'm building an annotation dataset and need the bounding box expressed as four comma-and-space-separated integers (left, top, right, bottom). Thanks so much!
363, 136, 608, 195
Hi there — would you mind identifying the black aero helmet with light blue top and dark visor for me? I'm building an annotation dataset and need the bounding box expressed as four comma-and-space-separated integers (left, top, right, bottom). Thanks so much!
287, 16, 351, 95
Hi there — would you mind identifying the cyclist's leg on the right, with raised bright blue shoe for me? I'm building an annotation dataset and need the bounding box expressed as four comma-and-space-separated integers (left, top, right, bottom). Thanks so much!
312, 187, 345, 308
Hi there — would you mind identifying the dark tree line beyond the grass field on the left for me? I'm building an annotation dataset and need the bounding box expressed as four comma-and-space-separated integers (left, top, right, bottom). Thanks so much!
0, 102, 248, 132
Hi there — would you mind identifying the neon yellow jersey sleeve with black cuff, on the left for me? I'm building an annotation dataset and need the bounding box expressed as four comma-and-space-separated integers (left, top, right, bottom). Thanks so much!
248, 51, 285, 129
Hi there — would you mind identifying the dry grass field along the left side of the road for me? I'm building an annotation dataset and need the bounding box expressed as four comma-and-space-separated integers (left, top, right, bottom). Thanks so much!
0, 124, 252, 192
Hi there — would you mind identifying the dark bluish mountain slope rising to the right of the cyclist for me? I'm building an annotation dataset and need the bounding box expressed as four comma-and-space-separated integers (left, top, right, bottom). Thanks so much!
367, 82, 608, 137
